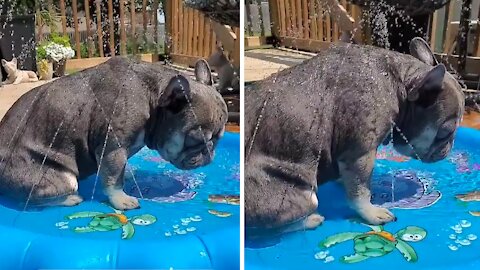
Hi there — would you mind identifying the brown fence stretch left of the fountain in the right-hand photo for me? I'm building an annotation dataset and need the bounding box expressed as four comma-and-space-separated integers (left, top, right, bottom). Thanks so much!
245, 0, 362, 51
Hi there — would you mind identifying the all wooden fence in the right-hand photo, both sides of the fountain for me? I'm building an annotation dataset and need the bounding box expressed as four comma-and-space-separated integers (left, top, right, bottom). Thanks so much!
245, 0, 480, 57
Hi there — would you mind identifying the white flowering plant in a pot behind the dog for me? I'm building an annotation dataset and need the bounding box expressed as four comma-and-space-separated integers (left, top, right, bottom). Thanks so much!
37, 33, 75, 77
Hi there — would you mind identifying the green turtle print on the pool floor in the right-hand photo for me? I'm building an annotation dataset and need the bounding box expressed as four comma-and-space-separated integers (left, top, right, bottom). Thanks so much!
319, 225, 427, 263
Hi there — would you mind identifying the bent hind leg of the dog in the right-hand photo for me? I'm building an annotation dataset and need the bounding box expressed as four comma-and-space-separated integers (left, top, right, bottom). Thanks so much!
245, 157, 323, 235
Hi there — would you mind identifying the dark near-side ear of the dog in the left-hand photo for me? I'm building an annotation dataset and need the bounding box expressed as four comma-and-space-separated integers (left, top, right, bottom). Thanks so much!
159, 75, 190, 111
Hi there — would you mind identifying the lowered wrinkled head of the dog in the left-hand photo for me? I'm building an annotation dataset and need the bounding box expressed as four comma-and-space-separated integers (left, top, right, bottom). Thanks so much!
154, 60, 228, 170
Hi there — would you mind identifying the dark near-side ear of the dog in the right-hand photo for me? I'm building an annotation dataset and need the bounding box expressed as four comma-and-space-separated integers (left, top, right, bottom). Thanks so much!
407, 64, 446, 108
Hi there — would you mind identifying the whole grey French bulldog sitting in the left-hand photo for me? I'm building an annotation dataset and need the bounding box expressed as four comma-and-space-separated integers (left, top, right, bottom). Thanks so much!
0, 57, 227, 210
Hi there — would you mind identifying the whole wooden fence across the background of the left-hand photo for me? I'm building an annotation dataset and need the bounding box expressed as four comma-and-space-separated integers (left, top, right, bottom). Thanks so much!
36, 0, 240, 69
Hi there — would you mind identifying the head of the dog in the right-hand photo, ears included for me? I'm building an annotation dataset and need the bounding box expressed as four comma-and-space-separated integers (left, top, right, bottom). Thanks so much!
394, 38, 465, 162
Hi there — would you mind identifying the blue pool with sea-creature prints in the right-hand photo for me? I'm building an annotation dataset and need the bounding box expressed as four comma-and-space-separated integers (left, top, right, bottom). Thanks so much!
245, 128, 480, 270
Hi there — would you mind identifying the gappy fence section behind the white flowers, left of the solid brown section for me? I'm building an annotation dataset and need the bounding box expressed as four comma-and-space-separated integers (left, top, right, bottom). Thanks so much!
36, 0, 163, 59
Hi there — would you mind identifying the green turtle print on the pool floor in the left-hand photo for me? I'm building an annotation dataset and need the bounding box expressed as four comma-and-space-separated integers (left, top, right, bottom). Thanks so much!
65, 209, 157, 239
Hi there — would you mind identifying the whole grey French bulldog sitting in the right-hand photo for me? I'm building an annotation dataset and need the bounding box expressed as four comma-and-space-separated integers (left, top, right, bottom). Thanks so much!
245, 38, 464, 234
